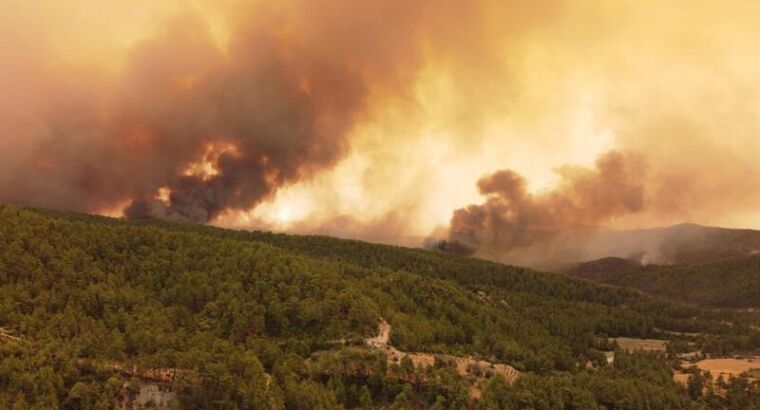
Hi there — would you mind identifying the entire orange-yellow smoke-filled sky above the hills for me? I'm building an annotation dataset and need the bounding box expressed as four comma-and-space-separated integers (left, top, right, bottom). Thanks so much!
0, 0, 760, 260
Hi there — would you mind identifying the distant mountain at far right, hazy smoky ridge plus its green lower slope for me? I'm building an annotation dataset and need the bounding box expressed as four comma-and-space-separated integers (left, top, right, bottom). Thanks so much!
554, 224, 760, 308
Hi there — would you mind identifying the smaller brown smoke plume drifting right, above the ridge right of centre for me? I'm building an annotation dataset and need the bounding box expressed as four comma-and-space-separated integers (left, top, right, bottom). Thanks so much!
437, 151, 646, 257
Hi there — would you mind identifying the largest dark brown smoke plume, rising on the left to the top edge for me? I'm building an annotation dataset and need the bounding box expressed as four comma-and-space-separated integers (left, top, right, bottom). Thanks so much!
0, 0, 548, 222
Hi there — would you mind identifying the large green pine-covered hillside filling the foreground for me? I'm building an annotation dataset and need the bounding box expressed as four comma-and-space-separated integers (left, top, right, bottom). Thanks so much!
0, 206, 760, 409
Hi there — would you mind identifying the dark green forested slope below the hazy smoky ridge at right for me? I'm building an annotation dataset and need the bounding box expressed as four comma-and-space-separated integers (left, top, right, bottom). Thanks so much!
566, 254, 760, 308
